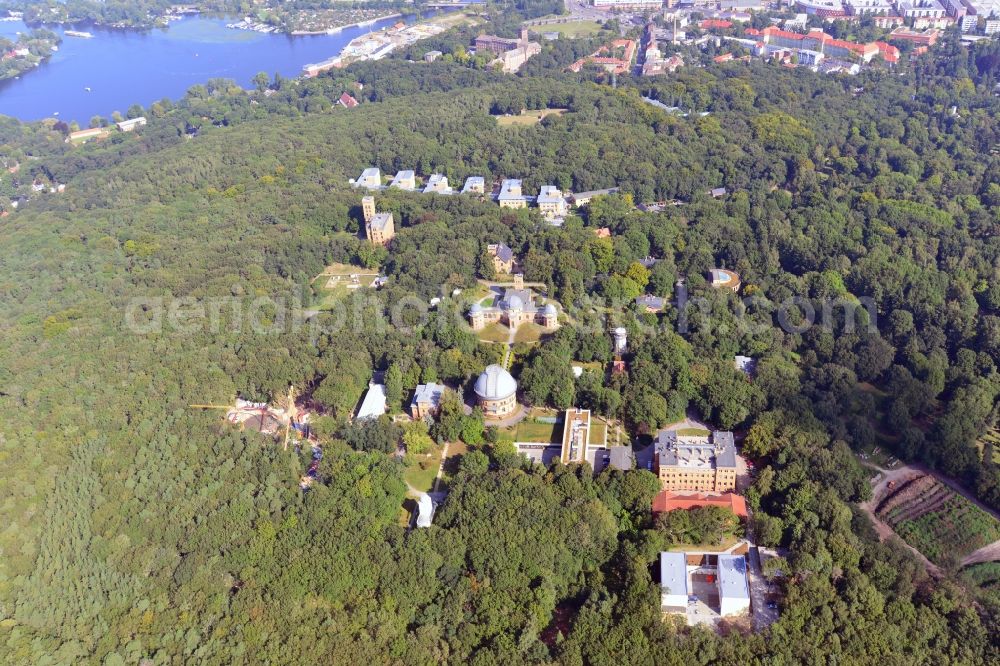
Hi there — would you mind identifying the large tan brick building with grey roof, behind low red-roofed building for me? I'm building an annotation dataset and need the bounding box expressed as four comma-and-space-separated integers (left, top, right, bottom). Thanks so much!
653, 430, 736, 493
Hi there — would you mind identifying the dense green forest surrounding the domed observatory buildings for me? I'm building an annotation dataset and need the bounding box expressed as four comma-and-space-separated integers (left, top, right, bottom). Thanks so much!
0, 11, 1000, 664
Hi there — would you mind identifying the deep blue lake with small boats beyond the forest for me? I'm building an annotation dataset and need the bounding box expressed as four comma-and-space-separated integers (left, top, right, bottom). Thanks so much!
0, 16, 414, 127
